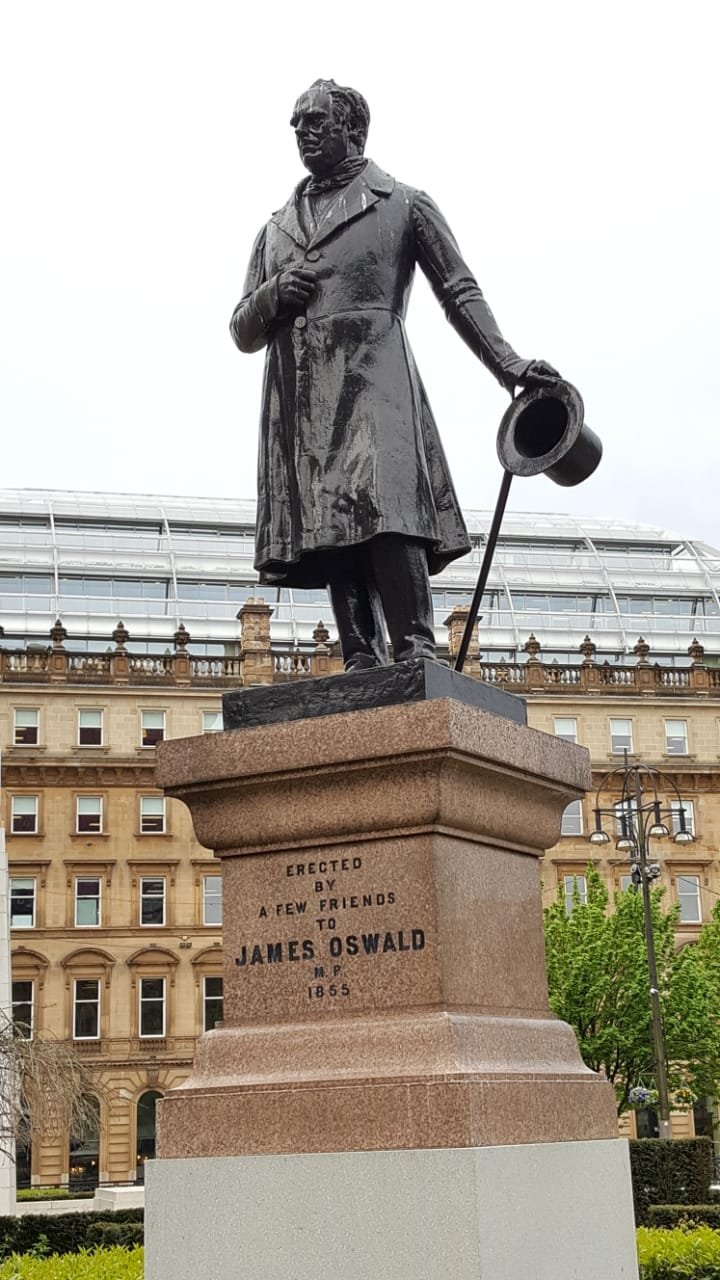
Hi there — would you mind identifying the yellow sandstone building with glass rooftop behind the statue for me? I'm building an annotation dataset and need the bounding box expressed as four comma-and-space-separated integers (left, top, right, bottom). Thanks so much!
0, 490, 720, 1185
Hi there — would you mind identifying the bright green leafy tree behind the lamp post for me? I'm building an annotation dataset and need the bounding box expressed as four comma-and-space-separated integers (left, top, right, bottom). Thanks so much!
544, 865, 720, 1114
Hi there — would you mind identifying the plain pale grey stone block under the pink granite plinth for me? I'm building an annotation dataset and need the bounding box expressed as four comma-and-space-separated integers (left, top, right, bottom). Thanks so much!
145, 1141, 638, 1280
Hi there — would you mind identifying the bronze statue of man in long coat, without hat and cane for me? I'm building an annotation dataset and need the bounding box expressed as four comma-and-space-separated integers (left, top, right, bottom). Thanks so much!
231, 81, 559, 671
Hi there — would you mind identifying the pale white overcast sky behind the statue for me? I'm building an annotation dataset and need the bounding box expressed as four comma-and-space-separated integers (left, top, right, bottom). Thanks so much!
0, 0, 720, 545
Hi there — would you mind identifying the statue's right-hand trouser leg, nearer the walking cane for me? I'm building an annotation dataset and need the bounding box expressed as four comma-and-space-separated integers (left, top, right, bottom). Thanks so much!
368, 534, 436, 662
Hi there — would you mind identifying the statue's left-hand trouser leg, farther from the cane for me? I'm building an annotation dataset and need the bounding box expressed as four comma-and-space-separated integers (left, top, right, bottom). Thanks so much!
328, 547, 389, 671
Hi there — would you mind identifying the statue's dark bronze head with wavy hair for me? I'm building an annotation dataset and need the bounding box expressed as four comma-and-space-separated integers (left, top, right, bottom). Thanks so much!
290, 79, 370, 178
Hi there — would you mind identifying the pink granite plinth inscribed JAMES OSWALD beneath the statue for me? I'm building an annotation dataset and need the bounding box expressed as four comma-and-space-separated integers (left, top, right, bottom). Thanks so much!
158, 699, 618, 1158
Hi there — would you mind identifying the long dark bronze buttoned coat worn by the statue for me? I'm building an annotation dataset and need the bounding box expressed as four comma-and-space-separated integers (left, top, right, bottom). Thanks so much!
231, 161, 527, 588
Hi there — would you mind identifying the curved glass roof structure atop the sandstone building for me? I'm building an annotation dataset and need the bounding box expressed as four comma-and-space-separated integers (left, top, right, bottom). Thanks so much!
0, 489, 720, 666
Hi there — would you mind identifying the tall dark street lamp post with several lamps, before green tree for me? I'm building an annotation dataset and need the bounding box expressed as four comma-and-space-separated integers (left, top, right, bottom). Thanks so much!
589, 751, 694, 1138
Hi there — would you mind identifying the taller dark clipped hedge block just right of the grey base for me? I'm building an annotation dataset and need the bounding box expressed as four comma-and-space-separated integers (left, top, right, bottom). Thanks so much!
630, 1138, 712, 1226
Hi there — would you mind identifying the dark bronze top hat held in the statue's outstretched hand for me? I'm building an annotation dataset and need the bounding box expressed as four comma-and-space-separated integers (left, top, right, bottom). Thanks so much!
497, 380, 602, 488
